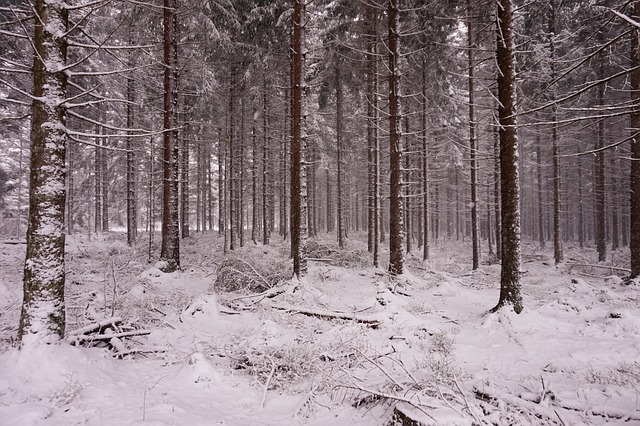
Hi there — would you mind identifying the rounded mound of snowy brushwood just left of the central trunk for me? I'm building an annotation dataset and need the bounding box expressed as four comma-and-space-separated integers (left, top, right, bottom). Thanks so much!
213, 257, 292, 293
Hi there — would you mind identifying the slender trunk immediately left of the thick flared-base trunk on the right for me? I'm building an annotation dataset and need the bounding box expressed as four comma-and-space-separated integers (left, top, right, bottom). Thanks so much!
467, 0, 480, 269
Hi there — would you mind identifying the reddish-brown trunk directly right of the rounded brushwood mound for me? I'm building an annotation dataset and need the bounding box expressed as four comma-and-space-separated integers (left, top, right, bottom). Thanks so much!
291, 0, 307, 278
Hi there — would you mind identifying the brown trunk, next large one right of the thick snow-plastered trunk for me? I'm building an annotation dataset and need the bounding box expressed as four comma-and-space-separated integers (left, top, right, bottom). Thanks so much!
160, 0, 180, 272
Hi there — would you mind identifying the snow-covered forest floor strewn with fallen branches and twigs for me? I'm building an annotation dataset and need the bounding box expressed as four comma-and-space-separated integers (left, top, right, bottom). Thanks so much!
0, 232, 640, 426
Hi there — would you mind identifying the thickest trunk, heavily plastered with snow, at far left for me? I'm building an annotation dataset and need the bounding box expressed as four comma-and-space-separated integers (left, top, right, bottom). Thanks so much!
18, 0, 69, 346
